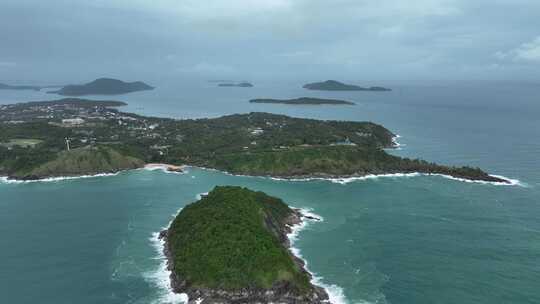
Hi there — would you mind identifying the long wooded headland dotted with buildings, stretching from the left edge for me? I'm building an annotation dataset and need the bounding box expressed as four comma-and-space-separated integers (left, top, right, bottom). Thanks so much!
0, 98, 508, 183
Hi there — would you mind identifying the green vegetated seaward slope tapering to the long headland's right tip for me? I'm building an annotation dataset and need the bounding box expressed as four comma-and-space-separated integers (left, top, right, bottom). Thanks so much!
203, 146, 498, 181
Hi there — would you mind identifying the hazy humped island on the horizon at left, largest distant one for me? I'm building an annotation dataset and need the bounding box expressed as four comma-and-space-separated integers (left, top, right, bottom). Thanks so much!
47, 78, 154, 96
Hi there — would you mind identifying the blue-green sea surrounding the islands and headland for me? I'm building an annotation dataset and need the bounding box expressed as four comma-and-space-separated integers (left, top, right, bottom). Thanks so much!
0, 80, 540, 304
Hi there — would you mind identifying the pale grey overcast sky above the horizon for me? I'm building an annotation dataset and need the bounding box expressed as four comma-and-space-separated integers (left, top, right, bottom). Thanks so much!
0, 0, 540, 81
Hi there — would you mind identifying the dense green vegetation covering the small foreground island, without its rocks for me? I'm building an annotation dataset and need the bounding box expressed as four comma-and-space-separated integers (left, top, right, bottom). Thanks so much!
167, 186, 312, 294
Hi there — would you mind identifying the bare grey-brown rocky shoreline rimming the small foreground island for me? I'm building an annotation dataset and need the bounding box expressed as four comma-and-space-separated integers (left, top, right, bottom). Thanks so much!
159, 209, 330, 304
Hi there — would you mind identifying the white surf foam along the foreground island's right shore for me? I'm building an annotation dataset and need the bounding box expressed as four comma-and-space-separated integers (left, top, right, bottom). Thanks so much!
287, 209, 348, 304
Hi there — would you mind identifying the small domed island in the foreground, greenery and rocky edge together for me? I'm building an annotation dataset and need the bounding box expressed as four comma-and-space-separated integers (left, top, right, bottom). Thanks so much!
160, 186, 329, 304
